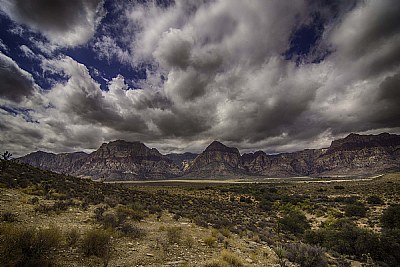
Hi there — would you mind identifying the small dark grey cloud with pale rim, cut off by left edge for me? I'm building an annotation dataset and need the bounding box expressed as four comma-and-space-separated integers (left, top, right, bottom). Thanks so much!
0, 52, 35, 102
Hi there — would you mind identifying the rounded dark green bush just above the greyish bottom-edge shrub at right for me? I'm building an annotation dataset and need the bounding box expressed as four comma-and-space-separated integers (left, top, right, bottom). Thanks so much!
278, 210, 311, 235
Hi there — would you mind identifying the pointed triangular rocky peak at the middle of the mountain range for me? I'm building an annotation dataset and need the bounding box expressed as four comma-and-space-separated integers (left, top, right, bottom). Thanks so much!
184, 141, 245, 178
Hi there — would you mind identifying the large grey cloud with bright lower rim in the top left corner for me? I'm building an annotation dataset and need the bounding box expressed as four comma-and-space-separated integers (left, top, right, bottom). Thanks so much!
0, 0, 104, 46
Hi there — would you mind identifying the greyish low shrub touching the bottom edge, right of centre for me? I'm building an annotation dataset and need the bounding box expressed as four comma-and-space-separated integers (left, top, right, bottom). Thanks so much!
285, 243, 328, 267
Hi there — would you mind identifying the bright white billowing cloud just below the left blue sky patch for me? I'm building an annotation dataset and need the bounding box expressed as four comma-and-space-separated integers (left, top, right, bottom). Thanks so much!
44, 57, 146, 132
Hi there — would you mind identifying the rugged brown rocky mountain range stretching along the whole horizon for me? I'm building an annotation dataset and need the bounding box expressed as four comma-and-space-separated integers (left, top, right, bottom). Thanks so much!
16, 133, 400, 181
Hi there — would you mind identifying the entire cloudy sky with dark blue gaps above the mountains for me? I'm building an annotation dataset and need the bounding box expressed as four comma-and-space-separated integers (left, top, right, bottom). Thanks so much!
0, 0, 400, 156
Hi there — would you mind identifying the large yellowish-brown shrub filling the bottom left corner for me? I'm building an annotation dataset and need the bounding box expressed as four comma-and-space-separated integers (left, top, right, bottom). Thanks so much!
0, 225, 61, 266
